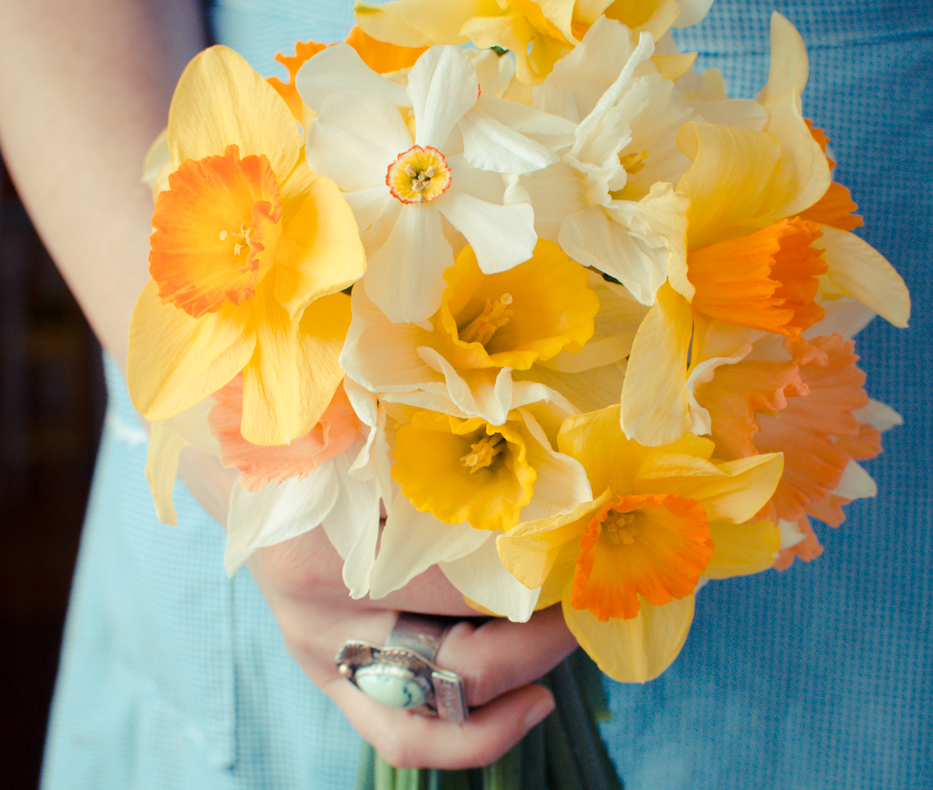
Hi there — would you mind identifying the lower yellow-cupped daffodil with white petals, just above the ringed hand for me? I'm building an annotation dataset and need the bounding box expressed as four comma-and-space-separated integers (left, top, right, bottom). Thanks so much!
370, 402, 592, 621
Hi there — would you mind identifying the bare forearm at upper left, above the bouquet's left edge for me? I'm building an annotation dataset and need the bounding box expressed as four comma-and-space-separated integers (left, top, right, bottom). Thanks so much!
0, 0, 204, 365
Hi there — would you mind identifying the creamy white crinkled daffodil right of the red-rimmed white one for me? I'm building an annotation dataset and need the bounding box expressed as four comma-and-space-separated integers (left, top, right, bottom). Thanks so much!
507, 18, 696, 304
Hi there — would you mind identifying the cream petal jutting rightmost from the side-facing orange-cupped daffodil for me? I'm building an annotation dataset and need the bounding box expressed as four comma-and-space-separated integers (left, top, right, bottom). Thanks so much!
818, 225, 910, 328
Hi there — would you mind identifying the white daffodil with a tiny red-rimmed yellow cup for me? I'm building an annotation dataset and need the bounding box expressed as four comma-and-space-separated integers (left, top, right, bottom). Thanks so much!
296, 46, 566, 321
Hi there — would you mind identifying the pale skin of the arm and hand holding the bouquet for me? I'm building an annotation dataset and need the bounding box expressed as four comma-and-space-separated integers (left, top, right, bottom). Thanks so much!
0, 0, 576, 769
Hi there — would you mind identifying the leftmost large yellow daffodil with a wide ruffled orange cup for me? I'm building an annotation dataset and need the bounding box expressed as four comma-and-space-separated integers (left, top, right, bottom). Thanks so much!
127, 47, 365, 444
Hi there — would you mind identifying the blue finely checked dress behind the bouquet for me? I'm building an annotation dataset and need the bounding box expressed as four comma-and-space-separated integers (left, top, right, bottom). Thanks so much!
43, 0, 933, 790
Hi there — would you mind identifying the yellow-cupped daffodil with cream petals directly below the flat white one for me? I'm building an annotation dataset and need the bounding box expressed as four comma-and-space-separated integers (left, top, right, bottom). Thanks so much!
340, 240, 643, 425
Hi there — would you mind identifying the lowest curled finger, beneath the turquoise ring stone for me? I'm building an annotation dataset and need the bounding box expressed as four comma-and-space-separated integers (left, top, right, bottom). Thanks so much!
325, 681, 554, 770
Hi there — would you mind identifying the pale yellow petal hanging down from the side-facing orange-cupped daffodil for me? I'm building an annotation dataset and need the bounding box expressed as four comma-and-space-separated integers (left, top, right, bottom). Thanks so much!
620, 285, 693, 446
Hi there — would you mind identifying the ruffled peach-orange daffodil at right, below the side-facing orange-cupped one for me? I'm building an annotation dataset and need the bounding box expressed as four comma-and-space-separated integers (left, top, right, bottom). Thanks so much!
693, 299, 899, 567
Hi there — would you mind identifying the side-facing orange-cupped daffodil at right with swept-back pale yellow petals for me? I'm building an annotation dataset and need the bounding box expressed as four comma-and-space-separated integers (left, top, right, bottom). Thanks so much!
621, 14, 909, 445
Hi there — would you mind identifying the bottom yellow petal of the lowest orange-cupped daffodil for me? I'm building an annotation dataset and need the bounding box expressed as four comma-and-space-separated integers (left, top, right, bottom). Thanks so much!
564, 595, 693, 683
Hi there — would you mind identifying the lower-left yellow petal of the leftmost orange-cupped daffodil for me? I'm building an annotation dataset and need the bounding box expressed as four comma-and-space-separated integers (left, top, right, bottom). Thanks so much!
126, 280, 256, 422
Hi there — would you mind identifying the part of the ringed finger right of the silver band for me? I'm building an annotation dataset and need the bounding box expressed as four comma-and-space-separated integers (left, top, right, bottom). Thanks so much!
437, 606, 577, 707
